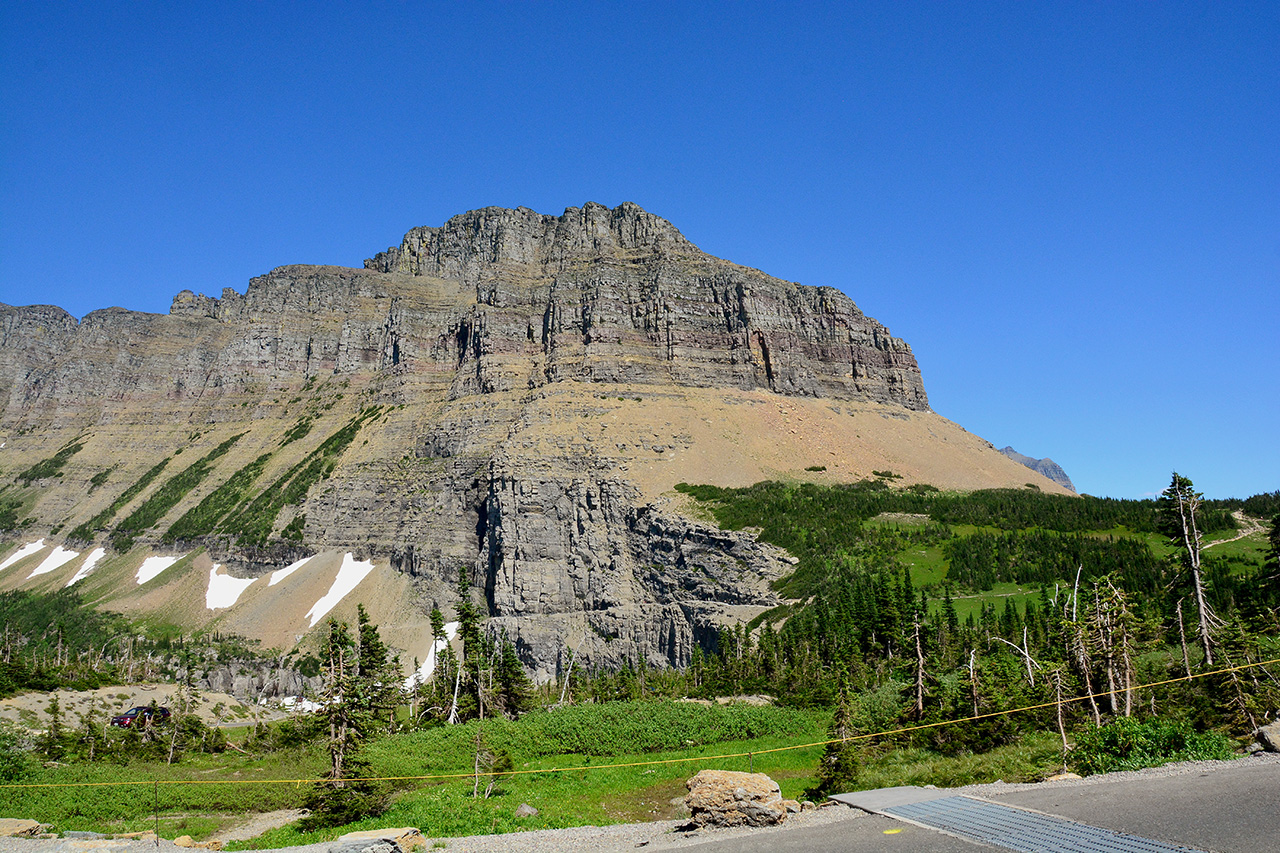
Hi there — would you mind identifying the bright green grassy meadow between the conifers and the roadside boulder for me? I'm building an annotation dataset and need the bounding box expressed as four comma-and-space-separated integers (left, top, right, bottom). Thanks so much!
0, 702, 1080, 849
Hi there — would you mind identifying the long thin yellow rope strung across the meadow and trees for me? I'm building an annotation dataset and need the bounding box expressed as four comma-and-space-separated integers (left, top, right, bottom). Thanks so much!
0, 657, 1280, 789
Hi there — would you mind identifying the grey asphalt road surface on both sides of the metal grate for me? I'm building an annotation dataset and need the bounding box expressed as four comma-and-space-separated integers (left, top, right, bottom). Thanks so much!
689, 761, 1280, 853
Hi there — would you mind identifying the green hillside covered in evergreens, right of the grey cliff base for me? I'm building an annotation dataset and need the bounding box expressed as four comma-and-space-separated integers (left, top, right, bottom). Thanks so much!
677, 478, 1280, 732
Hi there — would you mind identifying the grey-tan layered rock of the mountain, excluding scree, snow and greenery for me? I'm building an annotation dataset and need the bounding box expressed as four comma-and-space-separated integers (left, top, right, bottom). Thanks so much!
0, 204, 932, 678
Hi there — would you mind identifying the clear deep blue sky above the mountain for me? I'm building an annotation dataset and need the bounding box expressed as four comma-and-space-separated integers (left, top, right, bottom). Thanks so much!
0, 0, 1280, 497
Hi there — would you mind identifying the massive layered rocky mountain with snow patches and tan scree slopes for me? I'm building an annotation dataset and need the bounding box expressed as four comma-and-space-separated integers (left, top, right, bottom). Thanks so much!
0, 204, 1059, 679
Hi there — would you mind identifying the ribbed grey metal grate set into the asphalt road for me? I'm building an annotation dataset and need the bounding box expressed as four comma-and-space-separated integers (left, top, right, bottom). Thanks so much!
883, 797, 1194, 853
